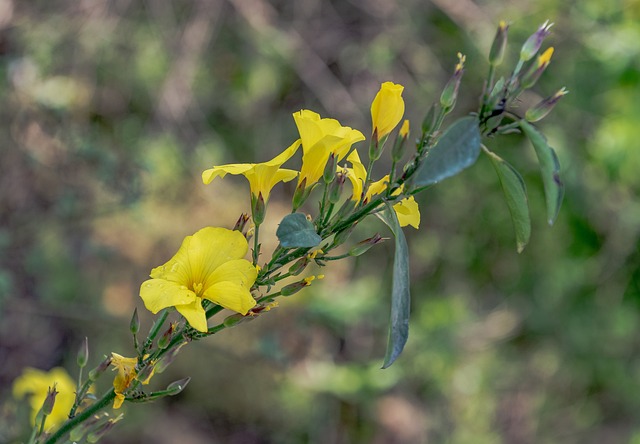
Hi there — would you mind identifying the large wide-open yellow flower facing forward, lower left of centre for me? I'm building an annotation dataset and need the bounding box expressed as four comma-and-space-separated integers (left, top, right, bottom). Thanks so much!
140, 227, 258, 332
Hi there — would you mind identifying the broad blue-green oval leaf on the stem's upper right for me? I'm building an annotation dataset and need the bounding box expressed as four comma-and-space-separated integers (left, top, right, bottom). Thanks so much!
413, 116, 480, 188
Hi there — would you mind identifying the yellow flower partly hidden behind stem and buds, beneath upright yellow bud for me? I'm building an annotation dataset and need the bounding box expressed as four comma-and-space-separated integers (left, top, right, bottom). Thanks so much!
343, 151, 420, 229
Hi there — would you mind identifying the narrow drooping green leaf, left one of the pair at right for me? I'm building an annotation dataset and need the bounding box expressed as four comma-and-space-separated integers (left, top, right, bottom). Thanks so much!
485, 150, 531, 253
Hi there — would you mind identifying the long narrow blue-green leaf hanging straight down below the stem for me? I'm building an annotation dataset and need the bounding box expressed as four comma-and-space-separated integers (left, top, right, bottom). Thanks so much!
378, 202, 411, 368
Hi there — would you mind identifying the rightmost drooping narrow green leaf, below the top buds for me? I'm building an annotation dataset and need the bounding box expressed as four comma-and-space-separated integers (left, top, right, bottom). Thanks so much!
520, 120, 564, 225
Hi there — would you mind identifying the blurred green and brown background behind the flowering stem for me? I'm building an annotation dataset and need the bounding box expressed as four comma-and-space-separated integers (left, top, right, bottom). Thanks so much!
0, 0, 640, 444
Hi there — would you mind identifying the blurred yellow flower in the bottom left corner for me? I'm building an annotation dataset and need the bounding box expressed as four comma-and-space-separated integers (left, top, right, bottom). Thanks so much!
13, 367, 76, 430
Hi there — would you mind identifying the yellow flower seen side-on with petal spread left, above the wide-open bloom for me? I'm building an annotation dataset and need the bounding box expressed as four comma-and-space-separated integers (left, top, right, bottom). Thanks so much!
202, 140, 300, 203
